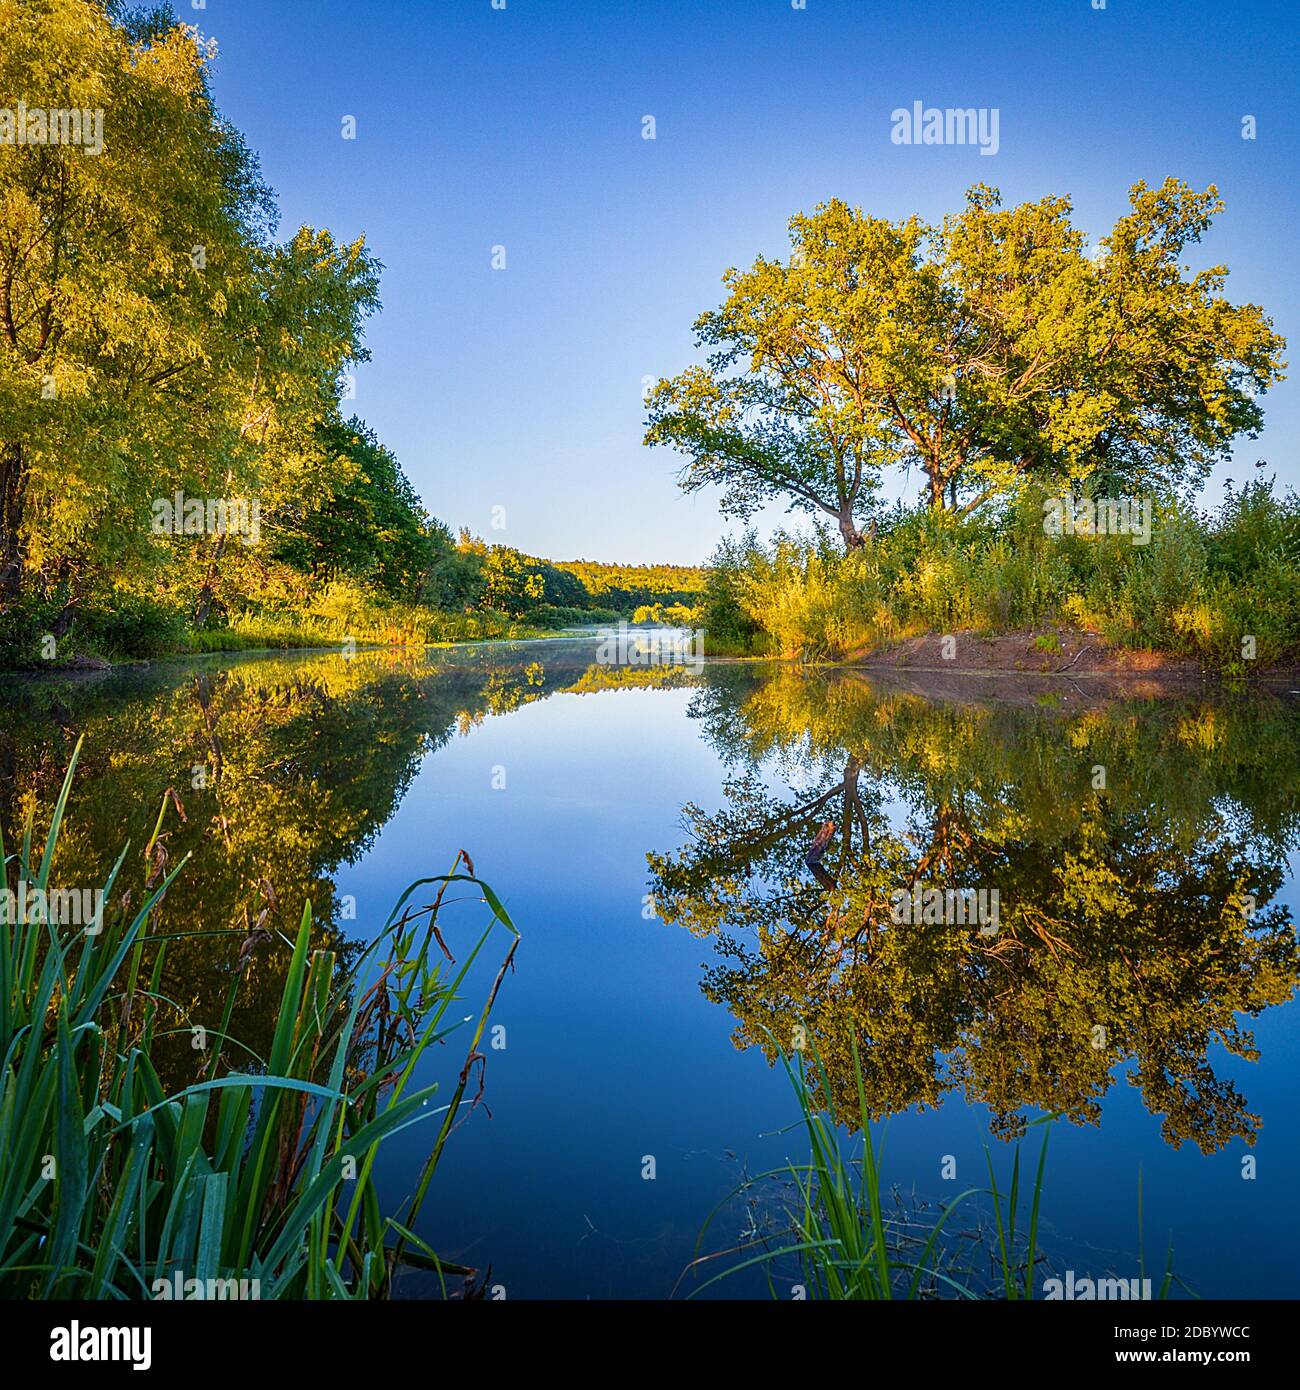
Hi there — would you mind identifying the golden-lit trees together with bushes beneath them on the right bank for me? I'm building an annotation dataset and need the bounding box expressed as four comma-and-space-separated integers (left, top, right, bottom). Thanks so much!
645, 178, 1300, 677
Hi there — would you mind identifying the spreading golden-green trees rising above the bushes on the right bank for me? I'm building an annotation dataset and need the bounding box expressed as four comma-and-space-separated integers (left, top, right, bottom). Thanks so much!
645, 179, 1283, 533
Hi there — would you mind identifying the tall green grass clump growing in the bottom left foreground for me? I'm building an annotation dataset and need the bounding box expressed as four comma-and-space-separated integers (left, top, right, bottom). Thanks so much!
0, 745, 517, 1300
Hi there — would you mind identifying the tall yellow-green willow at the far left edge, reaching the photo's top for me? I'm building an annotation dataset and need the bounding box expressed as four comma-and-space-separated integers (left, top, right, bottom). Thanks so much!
0, 0, 267, 606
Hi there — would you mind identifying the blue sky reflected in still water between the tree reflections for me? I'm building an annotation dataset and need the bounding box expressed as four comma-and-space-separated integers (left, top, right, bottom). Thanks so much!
338, 672, 1300, 1297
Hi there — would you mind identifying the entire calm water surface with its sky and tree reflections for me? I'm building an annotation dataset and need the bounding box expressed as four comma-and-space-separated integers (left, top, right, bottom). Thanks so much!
0, 639, 1300, 1298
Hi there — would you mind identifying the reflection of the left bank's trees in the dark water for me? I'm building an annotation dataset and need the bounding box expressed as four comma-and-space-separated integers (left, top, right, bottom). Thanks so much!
0, 648, 639, 1080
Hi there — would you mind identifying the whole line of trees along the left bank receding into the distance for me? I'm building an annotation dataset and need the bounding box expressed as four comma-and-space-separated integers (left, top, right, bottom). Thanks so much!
0, 0, 688, 664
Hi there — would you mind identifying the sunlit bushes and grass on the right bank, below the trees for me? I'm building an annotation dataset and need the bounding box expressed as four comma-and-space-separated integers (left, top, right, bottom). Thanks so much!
702, 484, 1300, 673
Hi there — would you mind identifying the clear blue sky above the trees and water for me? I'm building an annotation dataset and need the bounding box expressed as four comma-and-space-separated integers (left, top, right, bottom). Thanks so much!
198, 0, 1300, 562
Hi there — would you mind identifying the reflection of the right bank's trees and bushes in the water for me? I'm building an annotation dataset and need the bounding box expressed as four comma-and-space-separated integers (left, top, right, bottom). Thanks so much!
651, 671, 1300, 1150
